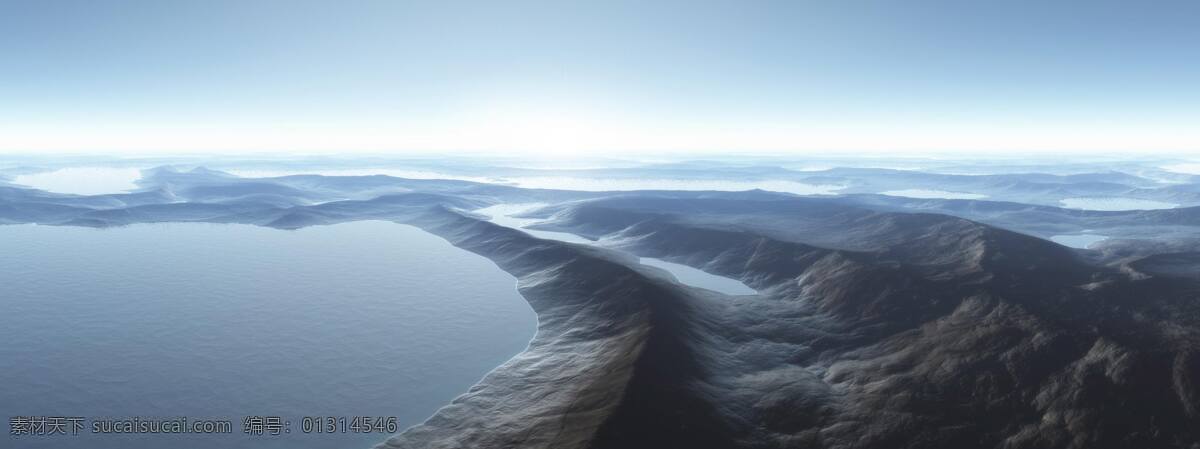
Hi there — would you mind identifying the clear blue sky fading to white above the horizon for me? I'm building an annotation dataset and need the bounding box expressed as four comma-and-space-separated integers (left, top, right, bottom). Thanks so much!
0, 0, 1200, 157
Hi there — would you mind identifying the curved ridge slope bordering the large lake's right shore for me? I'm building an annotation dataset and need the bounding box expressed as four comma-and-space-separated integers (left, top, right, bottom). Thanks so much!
383, 208, 719, 448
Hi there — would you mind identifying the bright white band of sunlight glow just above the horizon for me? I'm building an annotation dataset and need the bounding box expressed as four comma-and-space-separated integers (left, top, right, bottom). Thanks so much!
0, 113, 1200, 156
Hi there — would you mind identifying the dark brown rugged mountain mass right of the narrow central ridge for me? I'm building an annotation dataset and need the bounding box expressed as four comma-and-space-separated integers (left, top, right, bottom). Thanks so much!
528, 196, 1200, 448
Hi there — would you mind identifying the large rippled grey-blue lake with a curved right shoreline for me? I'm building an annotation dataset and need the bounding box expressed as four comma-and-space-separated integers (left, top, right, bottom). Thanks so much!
0, 222, 536, 449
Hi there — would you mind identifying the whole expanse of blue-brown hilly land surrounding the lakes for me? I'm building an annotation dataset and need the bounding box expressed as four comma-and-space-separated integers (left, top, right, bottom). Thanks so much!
0, 168, 1200, 449
